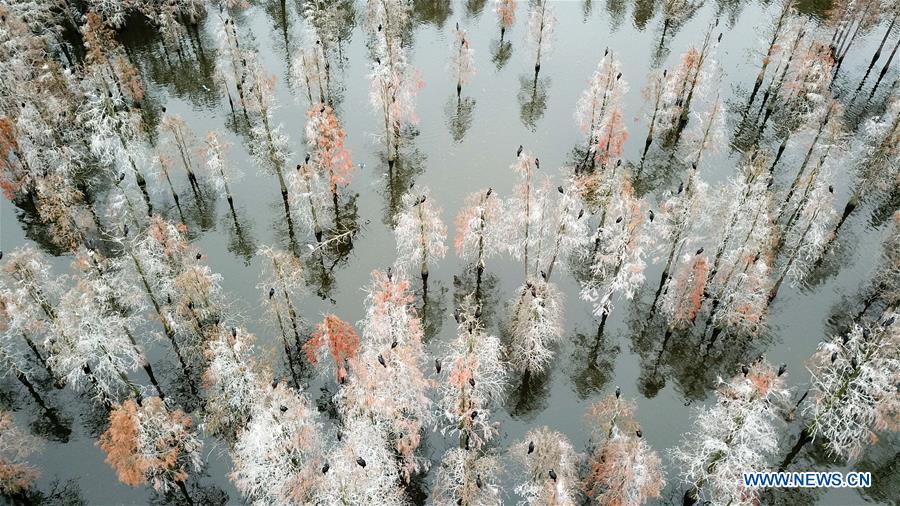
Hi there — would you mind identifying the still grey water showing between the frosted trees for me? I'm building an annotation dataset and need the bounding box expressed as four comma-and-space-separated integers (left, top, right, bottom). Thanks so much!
0, 0, 900, 504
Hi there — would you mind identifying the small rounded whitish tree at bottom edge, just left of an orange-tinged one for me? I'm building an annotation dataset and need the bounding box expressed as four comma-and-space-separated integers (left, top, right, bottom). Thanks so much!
510, 427, 582, 506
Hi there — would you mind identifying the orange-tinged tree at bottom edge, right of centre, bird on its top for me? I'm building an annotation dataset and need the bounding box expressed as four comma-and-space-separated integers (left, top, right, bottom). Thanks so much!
583, 395, 665, 506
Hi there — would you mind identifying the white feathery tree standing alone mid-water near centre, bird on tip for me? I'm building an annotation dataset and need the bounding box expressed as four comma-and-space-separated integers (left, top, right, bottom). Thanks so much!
394, 188, 447, 285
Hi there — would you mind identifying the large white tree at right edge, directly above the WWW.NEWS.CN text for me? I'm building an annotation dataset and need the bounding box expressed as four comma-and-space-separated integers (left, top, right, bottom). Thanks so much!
786, 311, 900, 463
